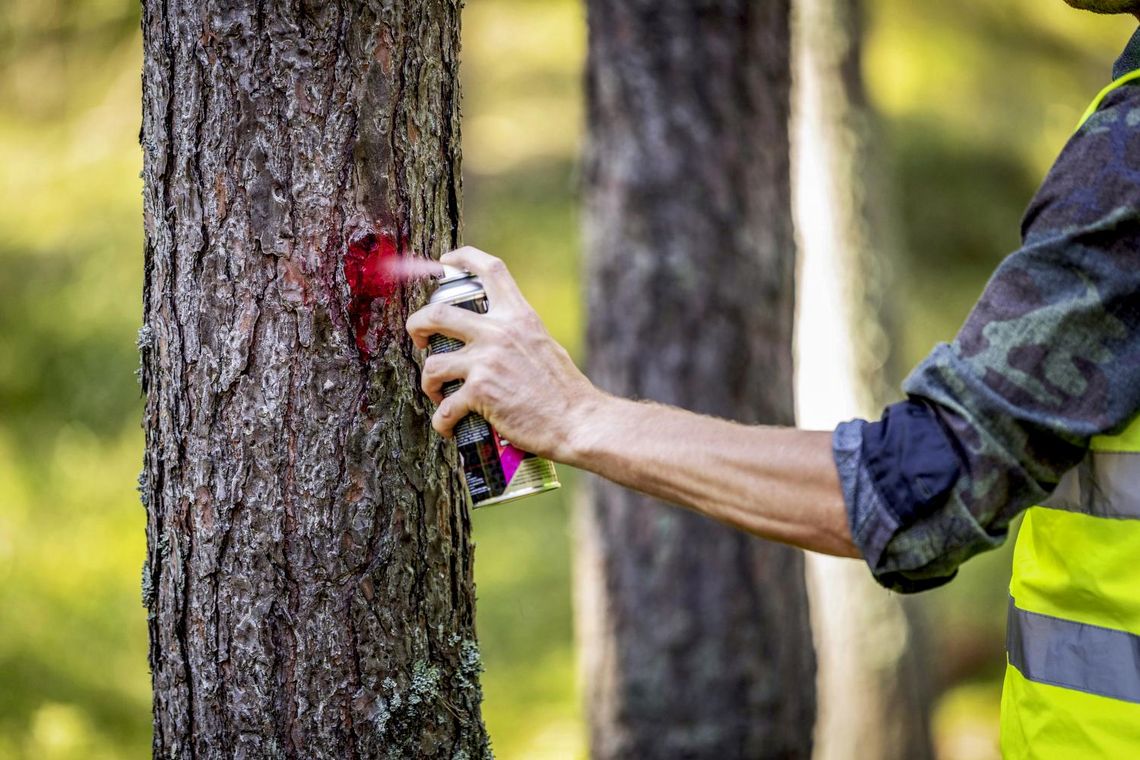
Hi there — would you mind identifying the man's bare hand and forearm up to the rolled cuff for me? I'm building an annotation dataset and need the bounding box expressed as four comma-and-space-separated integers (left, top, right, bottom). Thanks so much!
408, 248, 860, 557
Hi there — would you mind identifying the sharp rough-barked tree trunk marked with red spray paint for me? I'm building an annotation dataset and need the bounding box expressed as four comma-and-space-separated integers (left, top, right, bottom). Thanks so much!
139, 0, 488, 758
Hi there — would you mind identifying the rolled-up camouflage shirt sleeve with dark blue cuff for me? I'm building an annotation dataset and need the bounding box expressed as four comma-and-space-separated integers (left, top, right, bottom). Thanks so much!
833, 85, 1140, 591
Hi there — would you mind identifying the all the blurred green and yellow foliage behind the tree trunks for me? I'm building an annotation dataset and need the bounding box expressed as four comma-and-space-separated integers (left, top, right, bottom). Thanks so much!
0, 0, 1133, 760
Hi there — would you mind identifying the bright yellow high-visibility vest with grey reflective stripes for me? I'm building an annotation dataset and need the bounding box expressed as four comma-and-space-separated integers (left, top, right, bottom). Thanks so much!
1001, 71, 1140, 747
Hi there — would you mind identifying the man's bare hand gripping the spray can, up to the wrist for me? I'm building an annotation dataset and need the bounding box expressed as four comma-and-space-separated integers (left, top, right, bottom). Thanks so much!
407, 247, 602, 461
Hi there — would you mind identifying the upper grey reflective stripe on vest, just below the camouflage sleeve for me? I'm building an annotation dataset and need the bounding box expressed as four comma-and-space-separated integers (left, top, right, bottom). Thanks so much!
1041, 451, 1140, 520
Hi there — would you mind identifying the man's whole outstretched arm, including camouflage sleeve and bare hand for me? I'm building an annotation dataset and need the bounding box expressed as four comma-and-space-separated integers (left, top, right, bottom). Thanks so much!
408, 84, 1140, 591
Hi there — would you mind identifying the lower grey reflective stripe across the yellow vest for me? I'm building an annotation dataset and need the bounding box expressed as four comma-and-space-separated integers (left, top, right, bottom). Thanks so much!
1005, 598, 1140, 703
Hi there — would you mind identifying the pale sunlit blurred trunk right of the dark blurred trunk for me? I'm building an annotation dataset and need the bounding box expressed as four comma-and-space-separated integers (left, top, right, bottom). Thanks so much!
793, 0, 931, 760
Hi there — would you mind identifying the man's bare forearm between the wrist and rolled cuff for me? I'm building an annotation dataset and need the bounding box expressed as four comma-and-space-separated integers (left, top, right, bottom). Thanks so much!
555, 393, 860, 557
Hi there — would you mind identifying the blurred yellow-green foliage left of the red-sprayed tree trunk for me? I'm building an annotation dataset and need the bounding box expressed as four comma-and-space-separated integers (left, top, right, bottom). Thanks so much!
0, 0, 150, 759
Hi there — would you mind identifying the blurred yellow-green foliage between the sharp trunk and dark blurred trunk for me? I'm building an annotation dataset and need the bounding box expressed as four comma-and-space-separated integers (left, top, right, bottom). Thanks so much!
463, 0, 585, 760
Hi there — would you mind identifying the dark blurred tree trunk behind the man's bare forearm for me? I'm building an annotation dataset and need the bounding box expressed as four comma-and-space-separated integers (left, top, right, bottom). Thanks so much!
578, 0, 815, 760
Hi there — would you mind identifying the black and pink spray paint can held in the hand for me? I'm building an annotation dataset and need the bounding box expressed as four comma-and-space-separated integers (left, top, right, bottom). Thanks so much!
428, 265, 561, 508
